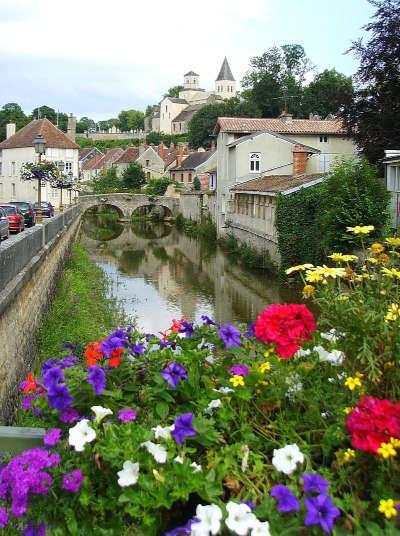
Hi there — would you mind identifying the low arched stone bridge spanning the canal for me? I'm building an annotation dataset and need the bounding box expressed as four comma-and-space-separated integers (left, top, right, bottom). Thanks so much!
79, 193, 180, 219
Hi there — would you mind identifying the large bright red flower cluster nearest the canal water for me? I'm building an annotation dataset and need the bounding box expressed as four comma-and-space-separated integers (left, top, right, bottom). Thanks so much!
254, 303, 317, 359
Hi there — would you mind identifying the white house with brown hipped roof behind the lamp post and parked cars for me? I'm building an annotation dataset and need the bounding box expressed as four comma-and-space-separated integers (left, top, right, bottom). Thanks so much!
0, 118, 79, 207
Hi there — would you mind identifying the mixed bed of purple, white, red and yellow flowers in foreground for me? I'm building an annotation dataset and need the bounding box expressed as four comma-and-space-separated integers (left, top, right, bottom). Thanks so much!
0, 227, 400, 536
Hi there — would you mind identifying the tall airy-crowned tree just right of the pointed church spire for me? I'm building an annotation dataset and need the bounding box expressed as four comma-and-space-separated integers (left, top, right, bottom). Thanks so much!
242, 44, 312, 117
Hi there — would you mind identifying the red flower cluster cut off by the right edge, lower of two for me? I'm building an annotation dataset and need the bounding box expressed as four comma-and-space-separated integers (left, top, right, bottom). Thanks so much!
346, 396, 400, 452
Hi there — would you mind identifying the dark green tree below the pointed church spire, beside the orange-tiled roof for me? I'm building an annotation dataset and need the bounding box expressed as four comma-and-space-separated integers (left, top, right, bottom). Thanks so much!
188, 97, 260, 148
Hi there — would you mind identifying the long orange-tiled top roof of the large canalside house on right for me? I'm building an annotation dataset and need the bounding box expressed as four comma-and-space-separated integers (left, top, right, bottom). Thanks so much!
214, 117, 346, 135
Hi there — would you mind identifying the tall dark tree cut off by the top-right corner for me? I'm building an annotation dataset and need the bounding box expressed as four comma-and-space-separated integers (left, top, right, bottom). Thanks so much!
342, 0, 400, 163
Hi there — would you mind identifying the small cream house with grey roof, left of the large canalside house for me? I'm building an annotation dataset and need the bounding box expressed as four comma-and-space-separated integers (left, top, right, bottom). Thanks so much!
169, 149, 217, 188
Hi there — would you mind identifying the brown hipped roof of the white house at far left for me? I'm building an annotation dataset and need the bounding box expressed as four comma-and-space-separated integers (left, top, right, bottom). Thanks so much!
0, 118, 80, 149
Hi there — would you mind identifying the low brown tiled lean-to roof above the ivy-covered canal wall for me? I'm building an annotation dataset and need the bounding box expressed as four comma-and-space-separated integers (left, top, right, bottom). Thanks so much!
230, 173, 326, 195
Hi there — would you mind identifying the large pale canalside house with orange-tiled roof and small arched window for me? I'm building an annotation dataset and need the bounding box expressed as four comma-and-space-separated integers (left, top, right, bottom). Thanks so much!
214, 113, 357, 235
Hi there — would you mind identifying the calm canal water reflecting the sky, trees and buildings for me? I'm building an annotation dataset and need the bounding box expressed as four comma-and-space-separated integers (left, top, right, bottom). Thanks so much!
80, 213, 298, 333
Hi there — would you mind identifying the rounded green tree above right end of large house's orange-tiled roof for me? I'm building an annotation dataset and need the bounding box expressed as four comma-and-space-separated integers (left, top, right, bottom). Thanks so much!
302, 69, 353, 117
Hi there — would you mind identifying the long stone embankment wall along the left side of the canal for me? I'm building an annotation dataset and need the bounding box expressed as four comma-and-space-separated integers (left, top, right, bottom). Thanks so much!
0, 205, 80, 424
